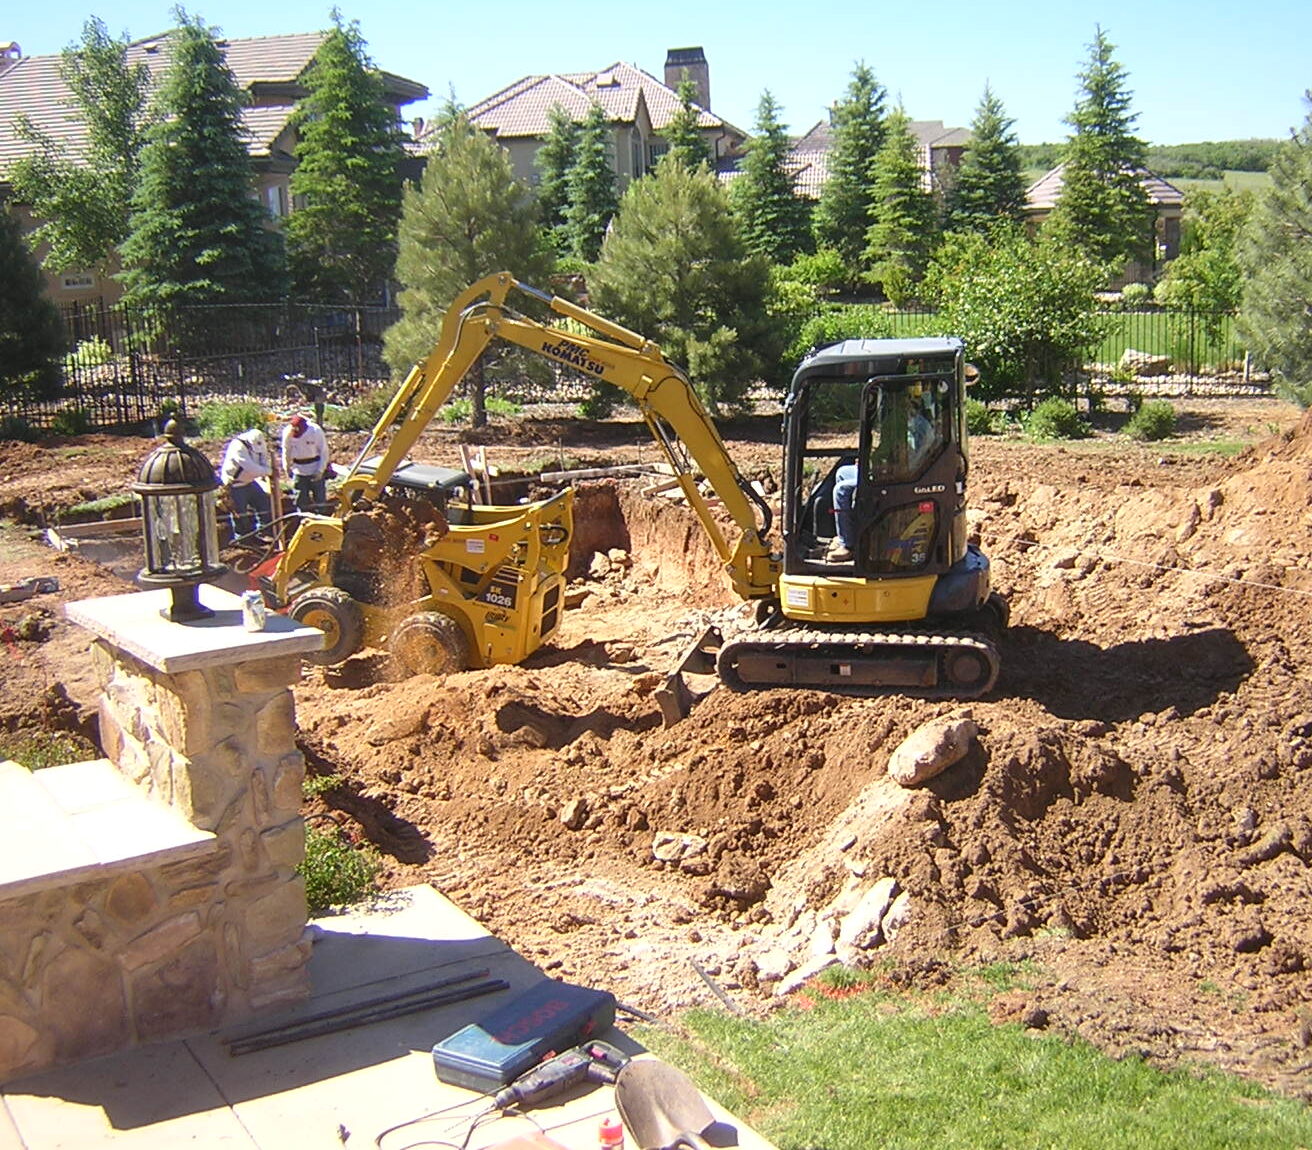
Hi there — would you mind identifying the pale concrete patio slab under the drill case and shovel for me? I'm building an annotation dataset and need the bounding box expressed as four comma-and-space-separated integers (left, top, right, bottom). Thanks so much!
0, 886, 771, 1150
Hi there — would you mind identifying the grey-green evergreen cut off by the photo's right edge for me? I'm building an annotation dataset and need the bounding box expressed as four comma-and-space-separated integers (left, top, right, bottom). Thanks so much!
1239, 92, 1312, 408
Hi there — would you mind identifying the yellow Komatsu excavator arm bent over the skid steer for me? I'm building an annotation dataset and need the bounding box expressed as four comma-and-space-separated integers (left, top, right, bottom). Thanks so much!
338, 271, 782, 599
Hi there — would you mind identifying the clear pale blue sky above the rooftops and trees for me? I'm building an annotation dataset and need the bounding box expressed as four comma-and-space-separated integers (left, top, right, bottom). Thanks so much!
12, 0, 1312, 144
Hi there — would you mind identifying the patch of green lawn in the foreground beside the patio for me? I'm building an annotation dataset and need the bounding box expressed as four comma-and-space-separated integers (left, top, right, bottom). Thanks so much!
639, 970, 1312, 1150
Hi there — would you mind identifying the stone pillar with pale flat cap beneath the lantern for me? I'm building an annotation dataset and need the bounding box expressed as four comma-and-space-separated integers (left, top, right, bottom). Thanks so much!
66, 585, 323, 1041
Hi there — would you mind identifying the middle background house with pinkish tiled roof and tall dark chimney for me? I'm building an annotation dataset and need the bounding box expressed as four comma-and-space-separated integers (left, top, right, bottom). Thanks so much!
468, 49, 747, 190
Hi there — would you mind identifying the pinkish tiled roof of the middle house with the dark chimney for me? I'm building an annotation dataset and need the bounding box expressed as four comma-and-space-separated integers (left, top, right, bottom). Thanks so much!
468, 63, 736, 138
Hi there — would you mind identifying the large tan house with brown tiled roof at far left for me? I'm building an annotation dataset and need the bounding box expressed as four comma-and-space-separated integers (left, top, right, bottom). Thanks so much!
0, 31, 428, 303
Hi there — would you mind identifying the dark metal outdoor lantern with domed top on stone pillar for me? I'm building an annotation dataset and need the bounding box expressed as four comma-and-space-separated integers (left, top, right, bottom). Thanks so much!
133, 420, 227, 623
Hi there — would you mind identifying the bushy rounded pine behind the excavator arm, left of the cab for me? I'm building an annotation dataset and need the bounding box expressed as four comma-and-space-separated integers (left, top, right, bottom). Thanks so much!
589, 160, 782, 409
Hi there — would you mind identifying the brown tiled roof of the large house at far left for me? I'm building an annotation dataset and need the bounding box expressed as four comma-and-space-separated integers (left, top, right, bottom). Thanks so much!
0, 31, 428, 173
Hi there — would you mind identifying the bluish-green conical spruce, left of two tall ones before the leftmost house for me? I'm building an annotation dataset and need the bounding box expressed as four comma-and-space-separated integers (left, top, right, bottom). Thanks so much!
122, 8, 283, 309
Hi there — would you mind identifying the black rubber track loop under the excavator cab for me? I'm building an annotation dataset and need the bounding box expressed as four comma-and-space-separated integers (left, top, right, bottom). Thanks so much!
718, 627, 1000, 699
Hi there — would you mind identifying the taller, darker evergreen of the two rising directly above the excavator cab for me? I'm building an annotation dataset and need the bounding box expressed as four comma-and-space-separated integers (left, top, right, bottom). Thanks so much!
815, 63, 886, 269
